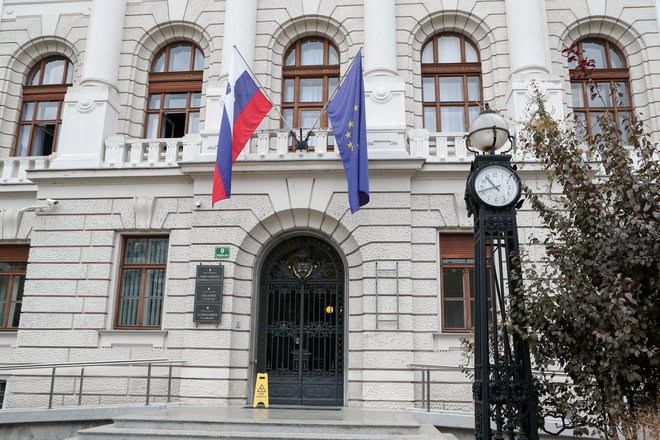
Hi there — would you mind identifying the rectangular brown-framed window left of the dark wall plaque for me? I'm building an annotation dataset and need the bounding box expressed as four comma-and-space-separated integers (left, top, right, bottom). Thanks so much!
115, 236, 168, 329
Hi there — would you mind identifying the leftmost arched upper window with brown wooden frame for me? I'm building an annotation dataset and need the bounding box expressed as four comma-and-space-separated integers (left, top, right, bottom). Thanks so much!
14, 56, 73, 156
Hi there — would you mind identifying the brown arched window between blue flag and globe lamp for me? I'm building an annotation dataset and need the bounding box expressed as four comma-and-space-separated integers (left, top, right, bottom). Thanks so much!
422, 33, 482, 133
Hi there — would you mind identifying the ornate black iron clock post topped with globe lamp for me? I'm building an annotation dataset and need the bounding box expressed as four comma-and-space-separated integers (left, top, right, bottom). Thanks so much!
465, 107, 538, 440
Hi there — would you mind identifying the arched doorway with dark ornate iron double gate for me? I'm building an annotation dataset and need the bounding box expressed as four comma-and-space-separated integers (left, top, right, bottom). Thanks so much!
257, 236, 344, 406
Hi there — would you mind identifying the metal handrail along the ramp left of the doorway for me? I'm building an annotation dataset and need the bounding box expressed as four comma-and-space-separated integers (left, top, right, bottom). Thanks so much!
0, 358, 186, 409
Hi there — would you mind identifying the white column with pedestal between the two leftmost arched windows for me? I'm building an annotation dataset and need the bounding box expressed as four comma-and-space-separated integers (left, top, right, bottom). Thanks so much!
51, 0, 126, 168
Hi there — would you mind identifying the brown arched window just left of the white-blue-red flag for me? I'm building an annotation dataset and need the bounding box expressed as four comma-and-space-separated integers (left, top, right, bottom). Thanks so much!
144, 42, 204, 139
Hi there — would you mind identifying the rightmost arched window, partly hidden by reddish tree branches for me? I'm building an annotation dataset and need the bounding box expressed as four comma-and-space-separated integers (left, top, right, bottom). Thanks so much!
569, 39, 632, 141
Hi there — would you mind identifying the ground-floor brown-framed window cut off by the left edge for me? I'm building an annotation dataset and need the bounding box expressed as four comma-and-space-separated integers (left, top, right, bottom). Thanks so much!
0, 245, 30, 330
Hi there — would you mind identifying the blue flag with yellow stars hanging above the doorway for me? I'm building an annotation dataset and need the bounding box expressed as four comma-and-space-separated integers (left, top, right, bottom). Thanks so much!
328, 50, 369, 213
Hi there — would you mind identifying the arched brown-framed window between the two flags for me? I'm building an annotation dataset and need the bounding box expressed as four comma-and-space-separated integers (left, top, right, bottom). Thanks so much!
282, 37, 339, 150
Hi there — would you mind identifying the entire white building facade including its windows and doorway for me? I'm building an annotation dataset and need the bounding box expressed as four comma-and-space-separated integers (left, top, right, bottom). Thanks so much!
0, 0, 660, 411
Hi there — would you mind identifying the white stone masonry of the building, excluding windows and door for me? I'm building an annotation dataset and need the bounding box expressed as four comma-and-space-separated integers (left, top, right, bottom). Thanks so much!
0, 0, 660, 411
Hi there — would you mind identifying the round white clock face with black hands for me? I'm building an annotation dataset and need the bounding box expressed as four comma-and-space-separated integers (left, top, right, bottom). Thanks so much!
472, 165, 520, 208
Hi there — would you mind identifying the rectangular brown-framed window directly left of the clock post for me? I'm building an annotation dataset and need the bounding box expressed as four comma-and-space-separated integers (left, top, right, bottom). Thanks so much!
440, 234, 474, 333
